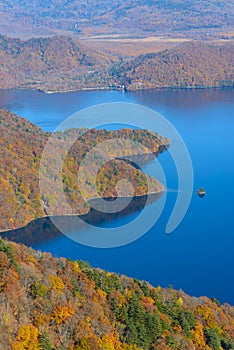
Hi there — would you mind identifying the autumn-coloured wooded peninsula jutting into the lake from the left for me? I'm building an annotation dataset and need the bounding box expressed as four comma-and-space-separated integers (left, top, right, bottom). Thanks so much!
0, 110, 169, 230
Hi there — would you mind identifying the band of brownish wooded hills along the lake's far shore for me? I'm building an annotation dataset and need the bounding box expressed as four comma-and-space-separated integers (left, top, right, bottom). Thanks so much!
0, 36, 234, 91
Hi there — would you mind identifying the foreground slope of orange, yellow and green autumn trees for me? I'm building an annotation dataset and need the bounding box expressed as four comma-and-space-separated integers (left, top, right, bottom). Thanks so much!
0, 240, 234, 350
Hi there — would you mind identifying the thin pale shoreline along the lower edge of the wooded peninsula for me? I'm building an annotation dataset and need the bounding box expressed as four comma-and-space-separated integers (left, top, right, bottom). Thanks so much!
0, 185, 165, 234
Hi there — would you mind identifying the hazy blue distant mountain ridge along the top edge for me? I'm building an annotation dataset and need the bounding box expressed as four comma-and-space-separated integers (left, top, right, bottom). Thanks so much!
0, 0, 234, 35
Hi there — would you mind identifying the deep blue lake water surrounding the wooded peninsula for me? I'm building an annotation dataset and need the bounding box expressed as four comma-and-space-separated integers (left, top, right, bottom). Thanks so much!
0, 89, 234, 305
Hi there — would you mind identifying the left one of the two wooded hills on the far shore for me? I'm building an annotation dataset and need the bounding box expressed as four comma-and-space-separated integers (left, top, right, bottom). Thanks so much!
0, 35, 113, 91
